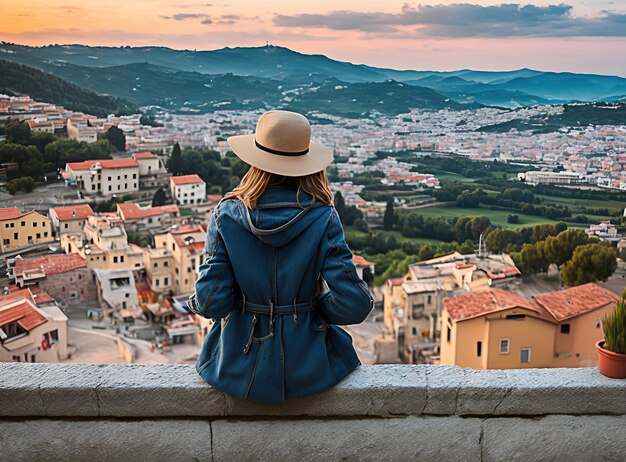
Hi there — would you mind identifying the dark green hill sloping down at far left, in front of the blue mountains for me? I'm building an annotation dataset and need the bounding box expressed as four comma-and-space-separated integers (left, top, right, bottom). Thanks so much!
0, 60, 137, 117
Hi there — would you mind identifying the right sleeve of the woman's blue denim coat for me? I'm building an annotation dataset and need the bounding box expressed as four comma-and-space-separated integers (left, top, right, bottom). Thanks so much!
318, 208, 374, 324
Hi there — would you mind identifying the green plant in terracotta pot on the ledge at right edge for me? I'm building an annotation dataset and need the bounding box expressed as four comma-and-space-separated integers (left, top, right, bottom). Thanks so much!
596, 291, 626, 379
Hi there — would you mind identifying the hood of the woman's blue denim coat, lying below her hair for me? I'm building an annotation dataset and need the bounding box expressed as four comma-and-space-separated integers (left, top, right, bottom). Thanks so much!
232, 185, 329, 247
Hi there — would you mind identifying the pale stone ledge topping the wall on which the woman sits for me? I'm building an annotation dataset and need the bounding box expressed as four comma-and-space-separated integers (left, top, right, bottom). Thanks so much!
0, 363, 626, 419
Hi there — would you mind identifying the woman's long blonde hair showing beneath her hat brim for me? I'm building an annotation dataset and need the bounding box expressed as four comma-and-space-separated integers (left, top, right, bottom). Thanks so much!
224, 166, 333, 210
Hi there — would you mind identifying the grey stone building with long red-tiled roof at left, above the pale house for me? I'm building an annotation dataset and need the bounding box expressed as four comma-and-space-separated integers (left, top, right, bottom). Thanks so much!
12, 254, 97, 307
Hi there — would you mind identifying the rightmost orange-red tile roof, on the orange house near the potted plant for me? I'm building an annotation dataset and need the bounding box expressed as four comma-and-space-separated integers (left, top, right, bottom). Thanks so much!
534, 282, 619, 321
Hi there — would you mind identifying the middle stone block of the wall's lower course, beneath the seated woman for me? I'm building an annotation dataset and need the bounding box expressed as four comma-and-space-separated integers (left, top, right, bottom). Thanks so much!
213, 416, 480, 462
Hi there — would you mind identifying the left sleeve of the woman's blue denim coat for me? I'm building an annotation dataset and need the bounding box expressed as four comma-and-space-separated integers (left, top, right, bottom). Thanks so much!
188, 205, 235, 319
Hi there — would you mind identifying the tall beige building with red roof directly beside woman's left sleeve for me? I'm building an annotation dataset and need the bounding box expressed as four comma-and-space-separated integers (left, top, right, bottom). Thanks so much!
144, 225, 206, 295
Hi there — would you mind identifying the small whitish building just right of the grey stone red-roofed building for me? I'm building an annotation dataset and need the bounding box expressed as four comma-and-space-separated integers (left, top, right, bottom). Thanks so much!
93, 269, 142, 320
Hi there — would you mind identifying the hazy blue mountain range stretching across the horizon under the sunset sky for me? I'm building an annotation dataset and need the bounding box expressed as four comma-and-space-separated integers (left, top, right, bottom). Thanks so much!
0, 42, 626, 117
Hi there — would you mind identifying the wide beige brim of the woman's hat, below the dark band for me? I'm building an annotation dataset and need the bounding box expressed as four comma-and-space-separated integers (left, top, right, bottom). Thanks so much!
228, 135, 333, 176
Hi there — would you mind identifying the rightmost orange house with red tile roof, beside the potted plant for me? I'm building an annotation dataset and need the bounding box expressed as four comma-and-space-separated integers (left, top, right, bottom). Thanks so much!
534, 283, 619, 367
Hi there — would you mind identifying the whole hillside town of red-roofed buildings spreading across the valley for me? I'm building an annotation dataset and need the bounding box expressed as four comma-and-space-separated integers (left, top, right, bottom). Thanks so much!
0, 96, 626, 369
